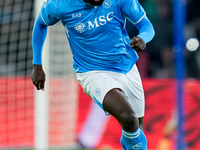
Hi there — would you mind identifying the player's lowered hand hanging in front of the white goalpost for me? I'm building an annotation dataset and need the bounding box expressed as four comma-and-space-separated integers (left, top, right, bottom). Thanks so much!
31, 65, 46, 91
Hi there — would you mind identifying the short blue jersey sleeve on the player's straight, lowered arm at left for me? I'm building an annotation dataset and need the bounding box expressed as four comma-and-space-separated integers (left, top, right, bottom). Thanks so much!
40, 0, 60, 25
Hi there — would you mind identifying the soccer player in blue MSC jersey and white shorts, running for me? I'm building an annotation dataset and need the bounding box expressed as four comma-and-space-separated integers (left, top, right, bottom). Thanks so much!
32, 0, 155, 150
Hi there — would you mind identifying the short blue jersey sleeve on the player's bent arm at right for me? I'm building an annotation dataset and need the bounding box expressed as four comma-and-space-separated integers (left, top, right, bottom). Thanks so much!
118, 0, 146, 24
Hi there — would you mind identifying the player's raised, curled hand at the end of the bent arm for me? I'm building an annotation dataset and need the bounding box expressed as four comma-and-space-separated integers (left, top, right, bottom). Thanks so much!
129, 36, 146, 51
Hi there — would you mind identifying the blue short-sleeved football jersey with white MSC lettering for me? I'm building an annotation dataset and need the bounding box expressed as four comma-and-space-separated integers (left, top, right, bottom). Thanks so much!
40, 0, 146, 74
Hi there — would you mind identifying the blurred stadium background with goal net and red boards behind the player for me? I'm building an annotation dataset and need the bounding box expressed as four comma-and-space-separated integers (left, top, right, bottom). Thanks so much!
0, 0, 200, 150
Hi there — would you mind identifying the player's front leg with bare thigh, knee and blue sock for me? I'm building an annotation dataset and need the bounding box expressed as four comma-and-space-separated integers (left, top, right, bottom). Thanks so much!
103, 89, 147, 150
